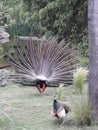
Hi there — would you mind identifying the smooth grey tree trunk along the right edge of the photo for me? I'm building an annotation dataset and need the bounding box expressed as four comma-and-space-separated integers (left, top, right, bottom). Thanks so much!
88, 0, 98, 120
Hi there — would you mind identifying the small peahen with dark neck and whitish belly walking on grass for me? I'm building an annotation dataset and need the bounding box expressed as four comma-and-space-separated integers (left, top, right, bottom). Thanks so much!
51, 97, 71, 124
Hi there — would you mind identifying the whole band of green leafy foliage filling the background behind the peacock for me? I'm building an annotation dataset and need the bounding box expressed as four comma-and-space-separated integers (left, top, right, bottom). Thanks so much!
0, 0, 88, 56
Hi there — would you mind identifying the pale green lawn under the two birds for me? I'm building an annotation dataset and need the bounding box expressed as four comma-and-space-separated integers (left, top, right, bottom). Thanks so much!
0, 85, 97, 130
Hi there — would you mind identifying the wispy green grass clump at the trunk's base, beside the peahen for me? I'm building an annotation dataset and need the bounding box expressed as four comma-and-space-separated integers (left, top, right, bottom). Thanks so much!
73, 95, 91, 126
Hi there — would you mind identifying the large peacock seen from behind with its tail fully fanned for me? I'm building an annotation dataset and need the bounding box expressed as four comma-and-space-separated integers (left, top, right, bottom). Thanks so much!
4, 37, 77, 93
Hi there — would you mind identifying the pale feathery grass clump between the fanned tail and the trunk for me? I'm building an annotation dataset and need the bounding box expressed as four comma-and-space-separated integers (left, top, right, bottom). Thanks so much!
73, 67, 88, 93
